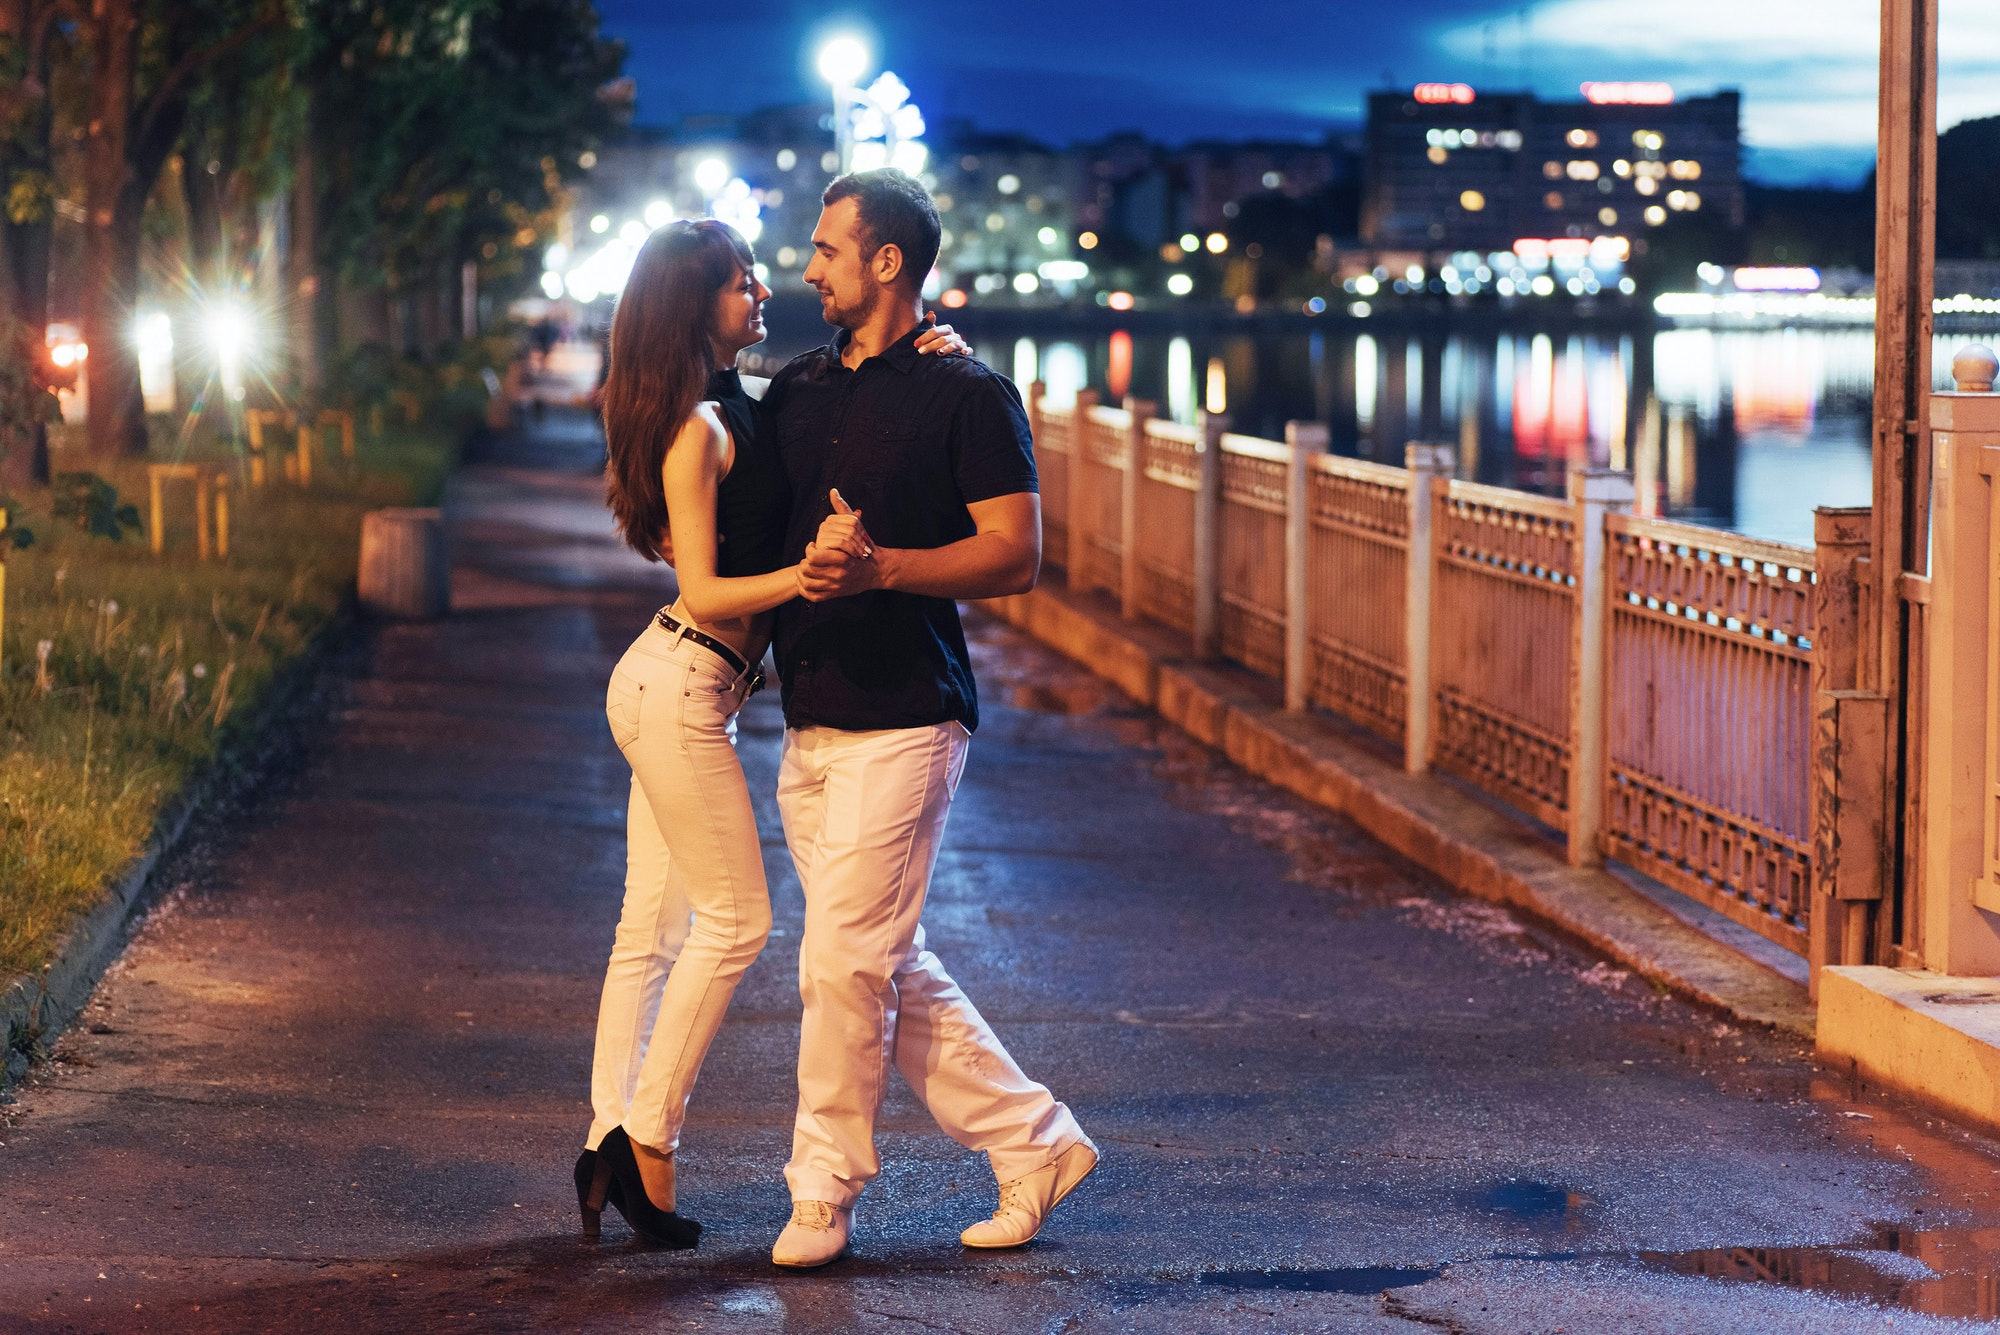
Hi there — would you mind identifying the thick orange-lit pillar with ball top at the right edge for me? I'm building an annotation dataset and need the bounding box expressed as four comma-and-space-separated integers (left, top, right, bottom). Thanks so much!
1916, 350, 2000, 973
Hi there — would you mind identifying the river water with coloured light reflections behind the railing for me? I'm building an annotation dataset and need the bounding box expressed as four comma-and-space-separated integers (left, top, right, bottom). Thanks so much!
1014, 330, 1974, 546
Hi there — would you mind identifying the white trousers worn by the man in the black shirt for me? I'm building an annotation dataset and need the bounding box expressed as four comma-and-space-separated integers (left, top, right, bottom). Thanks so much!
778, 723, 1084, 1207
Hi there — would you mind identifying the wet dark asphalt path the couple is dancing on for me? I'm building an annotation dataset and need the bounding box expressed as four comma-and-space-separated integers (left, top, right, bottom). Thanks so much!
0, 399, 2000, 1335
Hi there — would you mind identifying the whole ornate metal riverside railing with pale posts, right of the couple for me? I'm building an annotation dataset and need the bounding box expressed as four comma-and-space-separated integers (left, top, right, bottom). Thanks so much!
1030, 386, 1824, 953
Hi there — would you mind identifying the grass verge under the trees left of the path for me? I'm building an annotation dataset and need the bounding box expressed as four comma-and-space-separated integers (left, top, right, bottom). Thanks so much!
0, 426, 464, 987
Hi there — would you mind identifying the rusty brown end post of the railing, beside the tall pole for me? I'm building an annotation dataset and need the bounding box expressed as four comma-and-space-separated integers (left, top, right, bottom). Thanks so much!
1806, 506, 1888, 997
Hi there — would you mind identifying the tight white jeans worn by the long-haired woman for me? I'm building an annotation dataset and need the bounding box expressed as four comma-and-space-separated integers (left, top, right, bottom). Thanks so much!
584, 622, 770, 1149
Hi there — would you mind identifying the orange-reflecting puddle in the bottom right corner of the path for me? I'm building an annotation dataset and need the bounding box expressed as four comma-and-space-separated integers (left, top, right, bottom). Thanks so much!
1638, 1227, 2000, 1317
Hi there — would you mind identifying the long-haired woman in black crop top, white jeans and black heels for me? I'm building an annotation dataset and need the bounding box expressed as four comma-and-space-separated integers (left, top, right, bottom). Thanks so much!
576, 220, 964, 1247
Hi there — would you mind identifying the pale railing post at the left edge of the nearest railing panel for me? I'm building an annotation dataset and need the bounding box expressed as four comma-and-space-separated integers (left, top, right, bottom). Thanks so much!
1568, 468, 1632, 867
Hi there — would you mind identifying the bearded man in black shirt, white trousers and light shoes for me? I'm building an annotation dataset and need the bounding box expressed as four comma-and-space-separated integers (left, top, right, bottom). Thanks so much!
764, 170, 1098, 1269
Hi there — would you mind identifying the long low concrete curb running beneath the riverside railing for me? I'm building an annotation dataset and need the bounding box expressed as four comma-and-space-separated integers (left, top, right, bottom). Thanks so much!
978, 588, 1814, 1037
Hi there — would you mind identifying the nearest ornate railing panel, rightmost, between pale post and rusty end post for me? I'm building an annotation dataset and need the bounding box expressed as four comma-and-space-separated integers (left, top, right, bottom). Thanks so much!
1604, 516, 1814, 953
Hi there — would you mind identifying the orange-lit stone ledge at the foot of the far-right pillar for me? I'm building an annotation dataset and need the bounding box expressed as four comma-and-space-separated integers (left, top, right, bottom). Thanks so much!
1818, 965, 2000, 1131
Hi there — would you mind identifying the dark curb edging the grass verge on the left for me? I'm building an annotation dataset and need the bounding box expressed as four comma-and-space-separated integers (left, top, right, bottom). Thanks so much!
0, 598, 356, 1093
